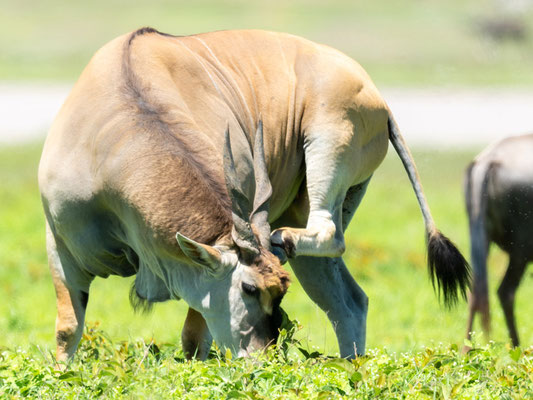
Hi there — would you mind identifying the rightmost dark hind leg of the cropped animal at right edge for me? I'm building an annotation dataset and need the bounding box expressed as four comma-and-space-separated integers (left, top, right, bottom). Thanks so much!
498, 254, 527, 346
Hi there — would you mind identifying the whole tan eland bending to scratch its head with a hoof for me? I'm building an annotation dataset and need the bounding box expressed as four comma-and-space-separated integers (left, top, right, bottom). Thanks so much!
39, 28, 469, 360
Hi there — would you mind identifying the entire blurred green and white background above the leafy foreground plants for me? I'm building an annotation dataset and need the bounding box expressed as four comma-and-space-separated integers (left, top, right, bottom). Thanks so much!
0, 0, 533, 353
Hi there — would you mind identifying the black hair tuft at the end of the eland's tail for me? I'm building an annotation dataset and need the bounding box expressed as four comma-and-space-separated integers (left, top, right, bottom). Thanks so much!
428, 231, 471, 307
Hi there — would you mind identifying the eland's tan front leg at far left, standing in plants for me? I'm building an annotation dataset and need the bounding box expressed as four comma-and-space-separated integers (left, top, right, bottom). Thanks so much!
46, 226, 90, 362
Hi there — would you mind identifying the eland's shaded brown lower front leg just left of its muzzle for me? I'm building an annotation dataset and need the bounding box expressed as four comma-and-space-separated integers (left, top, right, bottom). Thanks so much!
181, 308, 213, 360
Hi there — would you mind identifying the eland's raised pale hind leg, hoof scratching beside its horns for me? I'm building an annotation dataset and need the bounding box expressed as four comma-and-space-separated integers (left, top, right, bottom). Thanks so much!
271, 122, 388, 258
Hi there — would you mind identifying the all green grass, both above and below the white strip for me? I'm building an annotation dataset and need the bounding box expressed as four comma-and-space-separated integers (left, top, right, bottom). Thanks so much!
0, 0, 533, 399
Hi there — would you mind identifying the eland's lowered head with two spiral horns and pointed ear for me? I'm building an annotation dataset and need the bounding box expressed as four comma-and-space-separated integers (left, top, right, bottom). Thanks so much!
177, 121, 289, 356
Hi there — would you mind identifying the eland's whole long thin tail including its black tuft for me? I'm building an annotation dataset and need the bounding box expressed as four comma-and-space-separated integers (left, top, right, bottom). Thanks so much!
388, 115, 470, 306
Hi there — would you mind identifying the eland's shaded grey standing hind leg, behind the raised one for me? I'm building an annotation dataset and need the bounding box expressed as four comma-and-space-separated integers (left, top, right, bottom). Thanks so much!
290, 180, 369, 358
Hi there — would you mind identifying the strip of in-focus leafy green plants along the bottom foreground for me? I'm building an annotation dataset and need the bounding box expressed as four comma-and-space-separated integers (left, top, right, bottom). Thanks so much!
0, 328, 533, 399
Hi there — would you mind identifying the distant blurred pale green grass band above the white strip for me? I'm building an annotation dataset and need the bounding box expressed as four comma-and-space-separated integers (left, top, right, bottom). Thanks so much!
0, 0, 533, 86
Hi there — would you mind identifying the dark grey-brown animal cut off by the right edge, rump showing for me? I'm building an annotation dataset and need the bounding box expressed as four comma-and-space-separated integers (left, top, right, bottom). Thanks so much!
465, 134, 533, 346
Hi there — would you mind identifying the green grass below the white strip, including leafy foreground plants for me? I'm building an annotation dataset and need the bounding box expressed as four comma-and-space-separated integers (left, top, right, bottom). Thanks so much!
0, 144, 533, 398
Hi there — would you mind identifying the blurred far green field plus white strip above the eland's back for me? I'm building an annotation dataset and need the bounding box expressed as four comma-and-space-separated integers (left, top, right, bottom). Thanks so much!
0, 0, 533, 147
